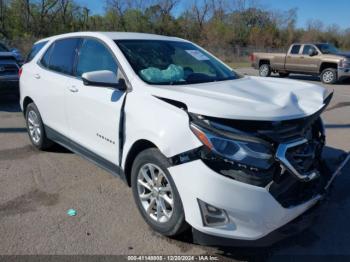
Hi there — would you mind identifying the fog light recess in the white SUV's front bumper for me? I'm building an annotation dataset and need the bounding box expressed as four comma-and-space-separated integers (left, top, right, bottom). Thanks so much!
197, 199, 230, 227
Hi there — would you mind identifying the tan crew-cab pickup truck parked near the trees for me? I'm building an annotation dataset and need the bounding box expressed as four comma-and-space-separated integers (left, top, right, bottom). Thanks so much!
251, 43, 350, 84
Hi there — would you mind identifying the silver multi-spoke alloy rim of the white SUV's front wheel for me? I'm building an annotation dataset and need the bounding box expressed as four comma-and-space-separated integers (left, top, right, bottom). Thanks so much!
137, 163, 174, 223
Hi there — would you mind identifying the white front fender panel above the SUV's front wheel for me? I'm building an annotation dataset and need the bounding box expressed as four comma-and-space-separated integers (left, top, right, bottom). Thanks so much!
121, 92, 202, 170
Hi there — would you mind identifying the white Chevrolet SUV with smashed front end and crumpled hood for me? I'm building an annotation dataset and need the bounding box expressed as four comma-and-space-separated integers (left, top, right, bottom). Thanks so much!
20, 32, 331, 245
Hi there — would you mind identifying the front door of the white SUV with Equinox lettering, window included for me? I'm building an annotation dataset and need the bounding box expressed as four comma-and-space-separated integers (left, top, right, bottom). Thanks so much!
66, 38, 125, 164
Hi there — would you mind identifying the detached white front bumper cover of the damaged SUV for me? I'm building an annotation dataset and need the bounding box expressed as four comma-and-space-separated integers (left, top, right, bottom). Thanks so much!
169, 157, 348, 245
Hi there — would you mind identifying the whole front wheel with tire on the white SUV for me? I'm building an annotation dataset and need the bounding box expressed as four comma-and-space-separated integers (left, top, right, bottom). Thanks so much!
131, 148, 188, 236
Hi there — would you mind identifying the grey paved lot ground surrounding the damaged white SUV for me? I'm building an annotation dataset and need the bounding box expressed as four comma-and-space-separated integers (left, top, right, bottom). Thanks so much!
0, 69, 350, 260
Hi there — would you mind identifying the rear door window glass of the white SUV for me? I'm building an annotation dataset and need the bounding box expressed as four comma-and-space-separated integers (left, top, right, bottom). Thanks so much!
41, 38, 80, 75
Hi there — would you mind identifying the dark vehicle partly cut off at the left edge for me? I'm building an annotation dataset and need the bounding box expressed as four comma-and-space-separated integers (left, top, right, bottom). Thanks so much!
0, 43, 23, 95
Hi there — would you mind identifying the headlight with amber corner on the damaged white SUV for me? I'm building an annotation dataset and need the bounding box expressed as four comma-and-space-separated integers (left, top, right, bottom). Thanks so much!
190, 123, 273, 169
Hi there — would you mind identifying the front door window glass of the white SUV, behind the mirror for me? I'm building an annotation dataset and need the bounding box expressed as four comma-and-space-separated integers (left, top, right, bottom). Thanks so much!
76, 39, 118, 77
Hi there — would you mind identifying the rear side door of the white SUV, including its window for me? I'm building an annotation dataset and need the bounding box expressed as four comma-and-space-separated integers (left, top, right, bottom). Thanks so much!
31, 38, 81, 135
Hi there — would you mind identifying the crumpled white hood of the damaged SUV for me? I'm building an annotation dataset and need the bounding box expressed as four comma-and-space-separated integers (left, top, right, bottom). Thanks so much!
151, 77, 328, 121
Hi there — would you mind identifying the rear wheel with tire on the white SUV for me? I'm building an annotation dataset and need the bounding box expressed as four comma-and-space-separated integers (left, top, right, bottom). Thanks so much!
26, 103, 53, 150
